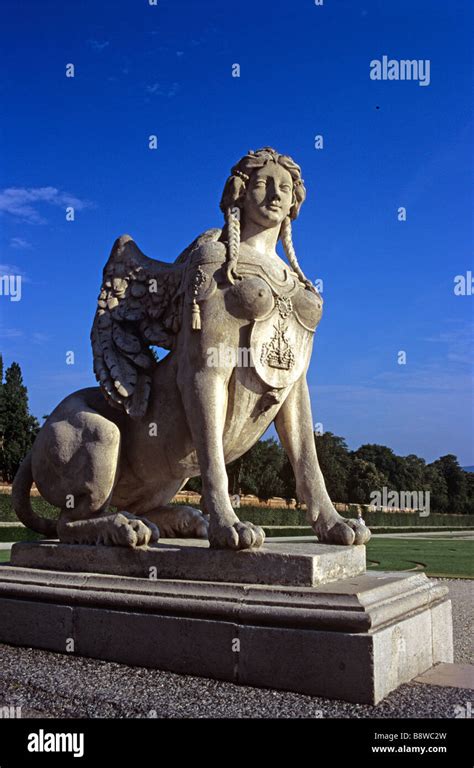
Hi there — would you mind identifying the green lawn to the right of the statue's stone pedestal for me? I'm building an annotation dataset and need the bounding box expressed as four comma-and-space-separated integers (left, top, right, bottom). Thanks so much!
367, 538, 474, 579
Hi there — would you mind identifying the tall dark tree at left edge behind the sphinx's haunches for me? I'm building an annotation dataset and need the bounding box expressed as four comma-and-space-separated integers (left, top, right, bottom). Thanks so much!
0, 363, 39, 482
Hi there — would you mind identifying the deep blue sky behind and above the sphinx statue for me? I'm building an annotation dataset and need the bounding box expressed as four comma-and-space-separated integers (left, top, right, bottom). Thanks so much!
0, 0, 474, 465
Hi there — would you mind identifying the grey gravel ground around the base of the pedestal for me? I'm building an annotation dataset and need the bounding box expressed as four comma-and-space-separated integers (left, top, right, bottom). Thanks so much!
0, 579, 474, 718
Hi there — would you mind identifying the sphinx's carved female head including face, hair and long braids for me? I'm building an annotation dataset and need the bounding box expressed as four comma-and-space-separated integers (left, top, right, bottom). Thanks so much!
220, 147, 309, 284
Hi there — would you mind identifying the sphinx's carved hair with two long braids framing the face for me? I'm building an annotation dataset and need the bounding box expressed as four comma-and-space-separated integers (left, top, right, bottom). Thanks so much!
220, 147, 314, 290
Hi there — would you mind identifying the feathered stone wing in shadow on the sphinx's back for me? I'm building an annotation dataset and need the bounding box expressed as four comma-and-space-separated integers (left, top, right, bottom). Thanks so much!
91, 235, 188, 419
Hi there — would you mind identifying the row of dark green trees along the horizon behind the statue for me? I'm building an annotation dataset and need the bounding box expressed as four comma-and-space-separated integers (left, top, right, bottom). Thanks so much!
0, 356, 474, 514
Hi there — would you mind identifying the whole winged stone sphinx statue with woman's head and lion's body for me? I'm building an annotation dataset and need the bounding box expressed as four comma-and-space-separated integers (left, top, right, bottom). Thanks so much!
12, 147, 370, 549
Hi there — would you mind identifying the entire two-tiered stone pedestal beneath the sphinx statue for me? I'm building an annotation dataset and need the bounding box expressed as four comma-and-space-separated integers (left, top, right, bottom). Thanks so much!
0, 541, 452, 703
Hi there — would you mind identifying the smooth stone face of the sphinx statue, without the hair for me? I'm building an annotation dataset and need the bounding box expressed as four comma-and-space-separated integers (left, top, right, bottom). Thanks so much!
243, 162, 293, 227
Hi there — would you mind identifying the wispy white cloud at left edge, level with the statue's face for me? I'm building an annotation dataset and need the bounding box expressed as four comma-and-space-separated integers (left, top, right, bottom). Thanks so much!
0, 187, 92, 224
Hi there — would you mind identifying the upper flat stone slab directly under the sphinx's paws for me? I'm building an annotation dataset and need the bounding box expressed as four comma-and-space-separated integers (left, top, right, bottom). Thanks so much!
11, 539, 365, 587
